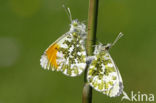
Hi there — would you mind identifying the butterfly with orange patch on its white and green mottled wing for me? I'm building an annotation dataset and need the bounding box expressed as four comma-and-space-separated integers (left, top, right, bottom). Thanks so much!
40, 8, 87, 77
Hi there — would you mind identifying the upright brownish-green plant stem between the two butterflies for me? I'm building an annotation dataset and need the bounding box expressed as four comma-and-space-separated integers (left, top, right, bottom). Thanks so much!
82, 0, 99, 103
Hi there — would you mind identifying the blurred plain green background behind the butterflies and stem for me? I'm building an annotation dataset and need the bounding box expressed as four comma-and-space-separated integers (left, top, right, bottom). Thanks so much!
0, 0, 156, 103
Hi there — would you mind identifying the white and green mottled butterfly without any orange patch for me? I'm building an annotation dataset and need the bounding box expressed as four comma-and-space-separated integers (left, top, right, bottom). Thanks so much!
87, 33, 123, 97
